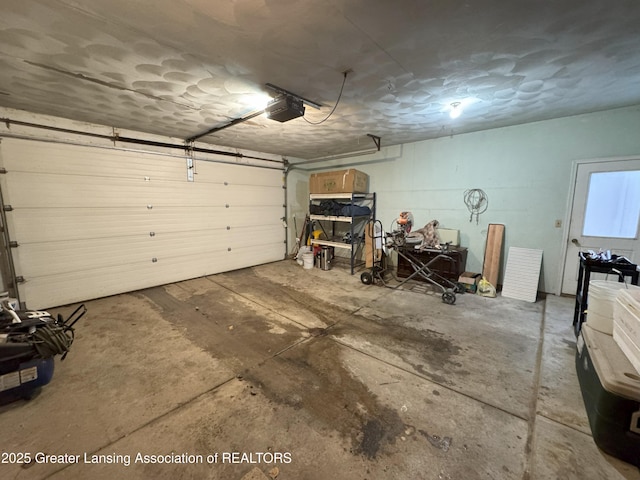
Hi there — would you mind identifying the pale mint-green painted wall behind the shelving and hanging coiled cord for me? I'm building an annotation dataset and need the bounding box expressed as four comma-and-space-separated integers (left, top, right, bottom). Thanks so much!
287, 107, 640, 293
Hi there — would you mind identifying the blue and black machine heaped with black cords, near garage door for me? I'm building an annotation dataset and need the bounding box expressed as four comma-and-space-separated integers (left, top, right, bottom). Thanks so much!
0, 298, 87, 404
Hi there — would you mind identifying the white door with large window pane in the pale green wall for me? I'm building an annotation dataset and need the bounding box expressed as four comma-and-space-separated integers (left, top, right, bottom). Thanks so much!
562, 158, 640, 295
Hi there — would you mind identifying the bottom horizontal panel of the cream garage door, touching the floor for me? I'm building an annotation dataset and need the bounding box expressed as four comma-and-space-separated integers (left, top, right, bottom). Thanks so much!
20, 246, 282, 309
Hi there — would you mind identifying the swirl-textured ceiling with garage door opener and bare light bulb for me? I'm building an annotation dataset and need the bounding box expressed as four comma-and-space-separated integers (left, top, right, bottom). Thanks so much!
0, 0, 640, 159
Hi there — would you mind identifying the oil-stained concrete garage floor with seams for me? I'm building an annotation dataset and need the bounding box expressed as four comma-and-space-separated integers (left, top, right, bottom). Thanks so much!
0, 260, 640, 480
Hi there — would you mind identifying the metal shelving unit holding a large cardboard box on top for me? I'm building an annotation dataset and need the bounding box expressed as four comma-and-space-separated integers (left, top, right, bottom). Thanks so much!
309, 193, 376, 275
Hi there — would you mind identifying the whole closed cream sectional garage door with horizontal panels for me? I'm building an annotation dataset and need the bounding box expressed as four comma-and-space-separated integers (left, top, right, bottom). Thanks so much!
0, 138, 286, 308
